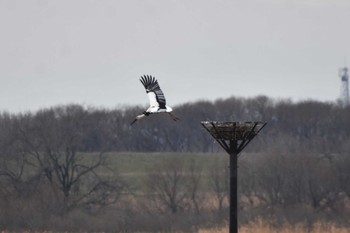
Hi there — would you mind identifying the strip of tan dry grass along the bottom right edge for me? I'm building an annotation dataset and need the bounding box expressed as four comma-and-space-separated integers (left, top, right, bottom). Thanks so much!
199, 220, 350, 233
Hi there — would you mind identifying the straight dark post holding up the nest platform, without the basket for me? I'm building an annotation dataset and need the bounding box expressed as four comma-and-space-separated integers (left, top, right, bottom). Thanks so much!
229, 140, 238, 233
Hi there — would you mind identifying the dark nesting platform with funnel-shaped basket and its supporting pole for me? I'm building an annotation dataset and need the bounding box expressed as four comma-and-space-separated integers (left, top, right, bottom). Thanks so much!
201, 121, 266, 233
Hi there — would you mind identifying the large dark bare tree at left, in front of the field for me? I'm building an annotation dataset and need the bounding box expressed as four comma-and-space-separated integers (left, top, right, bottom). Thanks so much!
17, 106, 123, 213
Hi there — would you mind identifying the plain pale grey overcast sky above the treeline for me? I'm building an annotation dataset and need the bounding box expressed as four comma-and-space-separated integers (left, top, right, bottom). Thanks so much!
0, 0, 350, 112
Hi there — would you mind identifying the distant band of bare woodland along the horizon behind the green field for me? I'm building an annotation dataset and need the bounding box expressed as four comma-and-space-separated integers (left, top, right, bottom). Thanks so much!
0, 96, 350, 154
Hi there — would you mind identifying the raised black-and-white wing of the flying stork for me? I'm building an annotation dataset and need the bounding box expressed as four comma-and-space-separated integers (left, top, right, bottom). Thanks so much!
140, 75, 166, 109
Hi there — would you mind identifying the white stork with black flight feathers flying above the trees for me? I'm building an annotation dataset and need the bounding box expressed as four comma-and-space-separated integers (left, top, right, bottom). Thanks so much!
130, 75, 179, 125
